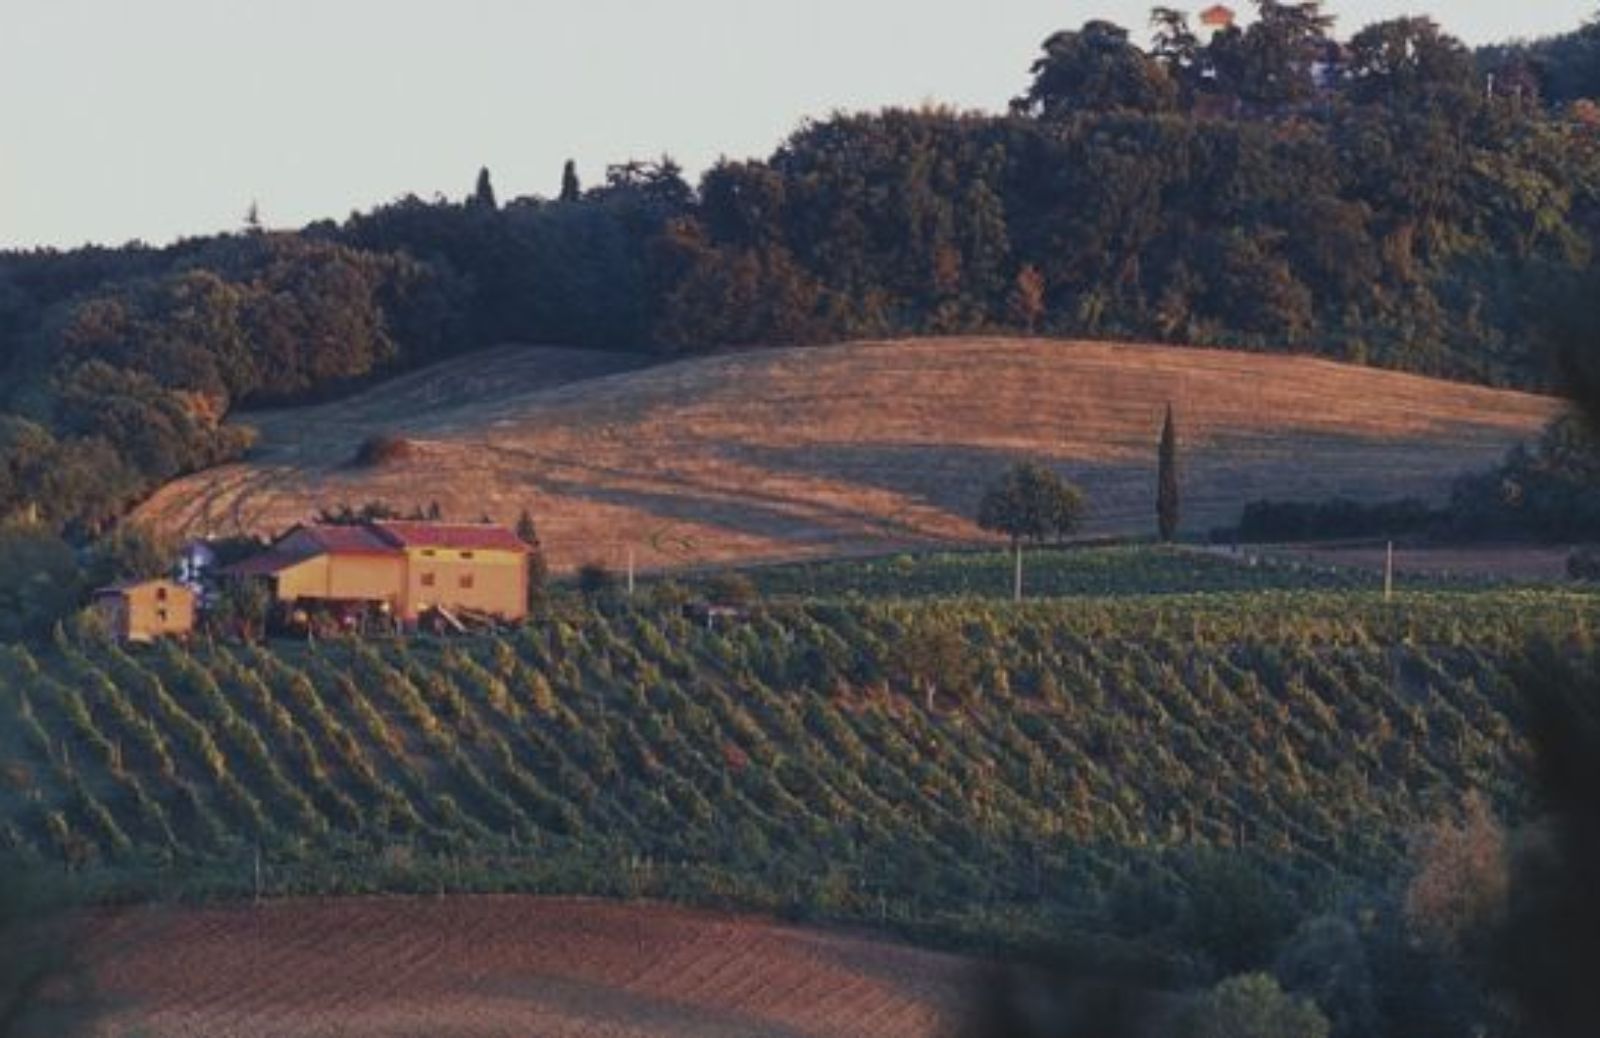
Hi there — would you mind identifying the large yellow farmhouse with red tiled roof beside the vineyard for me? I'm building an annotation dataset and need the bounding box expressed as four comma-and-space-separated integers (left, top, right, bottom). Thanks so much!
224, 520, 533, 624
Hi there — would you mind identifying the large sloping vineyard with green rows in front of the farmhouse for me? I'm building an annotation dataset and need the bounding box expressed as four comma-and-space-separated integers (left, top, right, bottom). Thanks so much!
0, 592, 1600, 966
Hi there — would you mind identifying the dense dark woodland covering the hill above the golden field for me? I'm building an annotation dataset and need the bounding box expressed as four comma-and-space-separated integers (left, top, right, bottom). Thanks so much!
0, 0, 1600, 539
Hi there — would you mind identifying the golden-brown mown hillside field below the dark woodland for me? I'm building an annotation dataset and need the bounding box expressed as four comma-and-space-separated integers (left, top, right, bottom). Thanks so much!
139, 339, 1558, 569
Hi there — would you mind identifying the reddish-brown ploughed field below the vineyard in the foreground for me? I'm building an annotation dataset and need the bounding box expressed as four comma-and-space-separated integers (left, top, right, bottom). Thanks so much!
96, 897, 973, 1038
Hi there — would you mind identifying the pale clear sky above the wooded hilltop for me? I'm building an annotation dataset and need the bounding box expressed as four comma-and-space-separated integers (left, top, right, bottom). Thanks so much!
0, 0, 1600, 248
